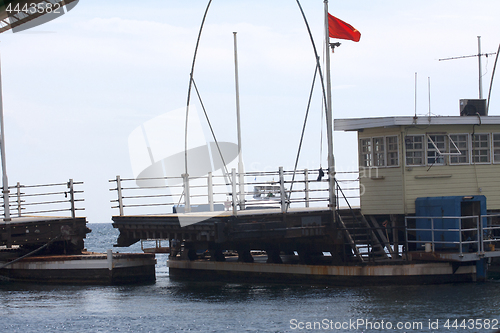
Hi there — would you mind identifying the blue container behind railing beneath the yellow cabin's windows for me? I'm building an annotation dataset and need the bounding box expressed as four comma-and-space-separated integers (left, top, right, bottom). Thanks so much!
415, 195, 487, 252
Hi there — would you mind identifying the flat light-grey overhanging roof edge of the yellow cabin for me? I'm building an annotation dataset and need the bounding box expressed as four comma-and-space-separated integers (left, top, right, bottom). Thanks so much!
334, 116, 500, 131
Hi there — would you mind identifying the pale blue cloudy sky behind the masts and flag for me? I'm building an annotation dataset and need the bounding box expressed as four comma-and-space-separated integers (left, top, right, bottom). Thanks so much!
0, 0, 500, 223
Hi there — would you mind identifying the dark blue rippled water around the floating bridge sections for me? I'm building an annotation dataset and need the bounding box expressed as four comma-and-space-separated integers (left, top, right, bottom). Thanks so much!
0, 224, 500, 333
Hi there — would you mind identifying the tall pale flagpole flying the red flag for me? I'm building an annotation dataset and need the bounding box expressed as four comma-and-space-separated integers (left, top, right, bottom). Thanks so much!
324, 0, 336, 210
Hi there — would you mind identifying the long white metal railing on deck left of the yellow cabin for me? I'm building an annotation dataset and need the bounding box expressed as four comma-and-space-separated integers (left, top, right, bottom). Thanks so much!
110, 167, 359, 216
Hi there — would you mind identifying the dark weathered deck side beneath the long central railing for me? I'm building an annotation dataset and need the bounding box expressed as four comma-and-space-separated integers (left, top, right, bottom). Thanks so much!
112, 207, 333, 247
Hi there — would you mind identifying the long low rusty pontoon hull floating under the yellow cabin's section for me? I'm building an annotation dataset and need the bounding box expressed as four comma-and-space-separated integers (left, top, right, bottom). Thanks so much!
168, 260, 476, 285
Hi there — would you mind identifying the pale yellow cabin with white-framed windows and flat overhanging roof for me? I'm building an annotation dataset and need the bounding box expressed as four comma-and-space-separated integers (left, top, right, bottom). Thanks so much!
335, 113, 500, 215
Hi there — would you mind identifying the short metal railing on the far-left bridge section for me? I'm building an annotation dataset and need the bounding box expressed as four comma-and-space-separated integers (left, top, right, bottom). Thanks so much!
0, 179, 84, 218
